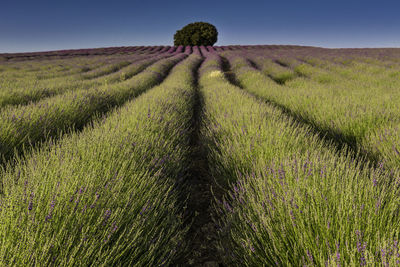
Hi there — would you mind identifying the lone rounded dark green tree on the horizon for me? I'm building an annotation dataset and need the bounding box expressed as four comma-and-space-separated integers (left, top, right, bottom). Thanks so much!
174, 22, 218, 46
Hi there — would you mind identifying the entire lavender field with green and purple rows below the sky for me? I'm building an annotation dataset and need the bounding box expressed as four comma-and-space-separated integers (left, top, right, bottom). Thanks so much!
0, 45, 400, 266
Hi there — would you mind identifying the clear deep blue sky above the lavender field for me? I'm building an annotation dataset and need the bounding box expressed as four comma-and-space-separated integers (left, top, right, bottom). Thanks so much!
0, 0, 400, 53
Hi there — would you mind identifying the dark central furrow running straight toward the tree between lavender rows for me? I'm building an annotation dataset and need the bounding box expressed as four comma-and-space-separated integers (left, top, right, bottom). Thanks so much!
172, 56, 221, 266
